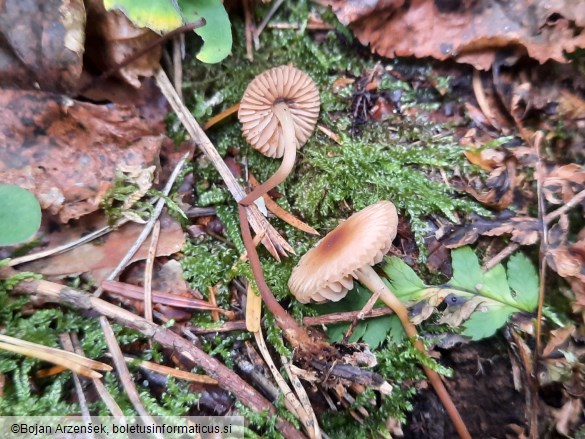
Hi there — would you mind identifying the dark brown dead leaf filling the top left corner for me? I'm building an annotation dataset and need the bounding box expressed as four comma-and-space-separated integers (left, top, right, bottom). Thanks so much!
0, 0, 85, 93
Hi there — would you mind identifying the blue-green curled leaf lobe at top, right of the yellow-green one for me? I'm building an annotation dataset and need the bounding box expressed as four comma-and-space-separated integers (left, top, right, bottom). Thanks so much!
178, 0, 232, 64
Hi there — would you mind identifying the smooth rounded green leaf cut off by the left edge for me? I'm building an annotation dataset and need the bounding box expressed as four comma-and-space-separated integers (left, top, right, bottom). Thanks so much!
0, 184, 41, 245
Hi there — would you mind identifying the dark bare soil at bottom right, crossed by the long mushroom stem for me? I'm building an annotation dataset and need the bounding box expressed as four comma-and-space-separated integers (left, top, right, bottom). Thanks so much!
404, 337, 528, 439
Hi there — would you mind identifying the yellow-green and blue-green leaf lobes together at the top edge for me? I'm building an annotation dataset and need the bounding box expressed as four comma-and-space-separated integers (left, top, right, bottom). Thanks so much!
104, 0, 232, 64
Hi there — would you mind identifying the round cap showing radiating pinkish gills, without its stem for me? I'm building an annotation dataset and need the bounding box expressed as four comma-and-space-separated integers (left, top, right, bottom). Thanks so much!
238, 66, 320, 158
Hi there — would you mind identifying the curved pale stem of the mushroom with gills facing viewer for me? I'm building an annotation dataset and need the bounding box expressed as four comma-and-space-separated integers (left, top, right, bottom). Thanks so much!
240, 102, 297, 206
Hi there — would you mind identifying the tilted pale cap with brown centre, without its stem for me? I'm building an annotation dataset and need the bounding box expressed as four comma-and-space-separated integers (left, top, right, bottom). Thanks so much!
288, 201, 398, 303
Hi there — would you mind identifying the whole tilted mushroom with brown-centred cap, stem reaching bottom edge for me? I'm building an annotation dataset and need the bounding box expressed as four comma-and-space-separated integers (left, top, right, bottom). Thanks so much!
288, 201, 471, 438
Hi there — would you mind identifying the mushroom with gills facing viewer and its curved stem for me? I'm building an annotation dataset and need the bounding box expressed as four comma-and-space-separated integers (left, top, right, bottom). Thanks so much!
238, 66, 320, 206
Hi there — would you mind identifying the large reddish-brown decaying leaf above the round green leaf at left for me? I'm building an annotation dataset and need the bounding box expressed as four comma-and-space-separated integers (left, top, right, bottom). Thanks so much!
0, 90, 163, 222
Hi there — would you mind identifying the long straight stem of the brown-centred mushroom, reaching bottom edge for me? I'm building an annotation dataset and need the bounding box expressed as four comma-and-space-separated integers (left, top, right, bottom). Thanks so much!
357, 265, 471, 439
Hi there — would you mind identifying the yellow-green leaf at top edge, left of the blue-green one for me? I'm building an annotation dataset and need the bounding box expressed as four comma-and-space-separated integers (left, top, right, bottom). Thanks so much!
104, 0, 183, 32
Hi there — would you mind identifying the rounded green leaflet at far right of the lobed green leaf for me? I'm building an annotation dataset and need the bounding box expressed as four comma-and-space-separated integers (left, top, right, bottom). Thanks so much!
508, 253, 538, 311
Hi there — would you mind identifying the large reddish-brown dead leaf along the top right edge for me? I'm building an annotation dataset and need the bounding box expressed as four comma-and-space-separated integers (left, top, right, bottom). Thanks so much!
327, 0, 585, 70
